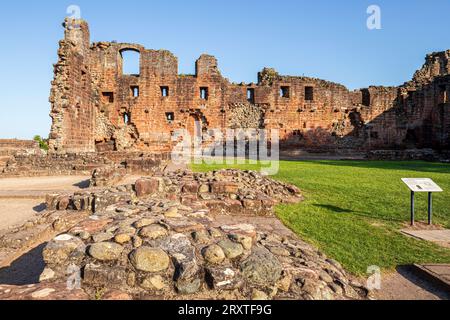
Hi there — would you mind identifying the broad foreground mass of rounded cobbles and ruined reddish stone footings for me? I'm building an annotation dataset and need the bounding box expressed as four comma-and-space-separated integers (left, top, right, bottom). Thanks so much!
0, 170, 370, 300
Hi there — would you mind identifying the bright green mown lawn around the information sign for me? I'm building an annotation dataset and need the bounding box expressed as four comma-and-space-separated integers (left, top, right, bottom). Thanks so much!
192, 161, 450, 275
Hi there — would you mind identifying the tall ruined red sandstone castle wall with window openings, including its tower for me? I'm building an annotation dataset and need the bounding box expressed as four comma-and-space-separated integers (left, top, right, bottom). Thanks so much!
50, 21, 450, 152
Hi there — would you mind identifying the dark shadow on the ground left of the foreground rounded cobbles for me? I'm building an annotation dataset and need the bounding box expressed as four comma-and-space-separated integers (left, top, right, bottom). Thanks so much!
0, 243, 47, 286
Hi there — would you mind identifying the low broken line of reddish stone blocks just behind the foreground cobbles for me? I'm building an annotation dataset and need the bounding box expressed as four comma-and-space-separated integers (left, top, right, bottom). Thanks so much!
46, 170, 302, 215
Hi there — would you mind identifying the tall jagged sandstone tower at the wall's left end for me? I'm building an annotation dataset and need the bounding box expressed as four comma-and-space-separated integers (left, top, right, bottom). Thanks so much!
49, 19, 95, 153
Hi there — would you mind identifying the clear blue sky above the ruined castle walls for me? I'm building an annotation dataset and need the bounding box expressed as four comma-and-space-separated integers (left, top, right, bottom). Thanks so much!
0, 0, 450, 139
